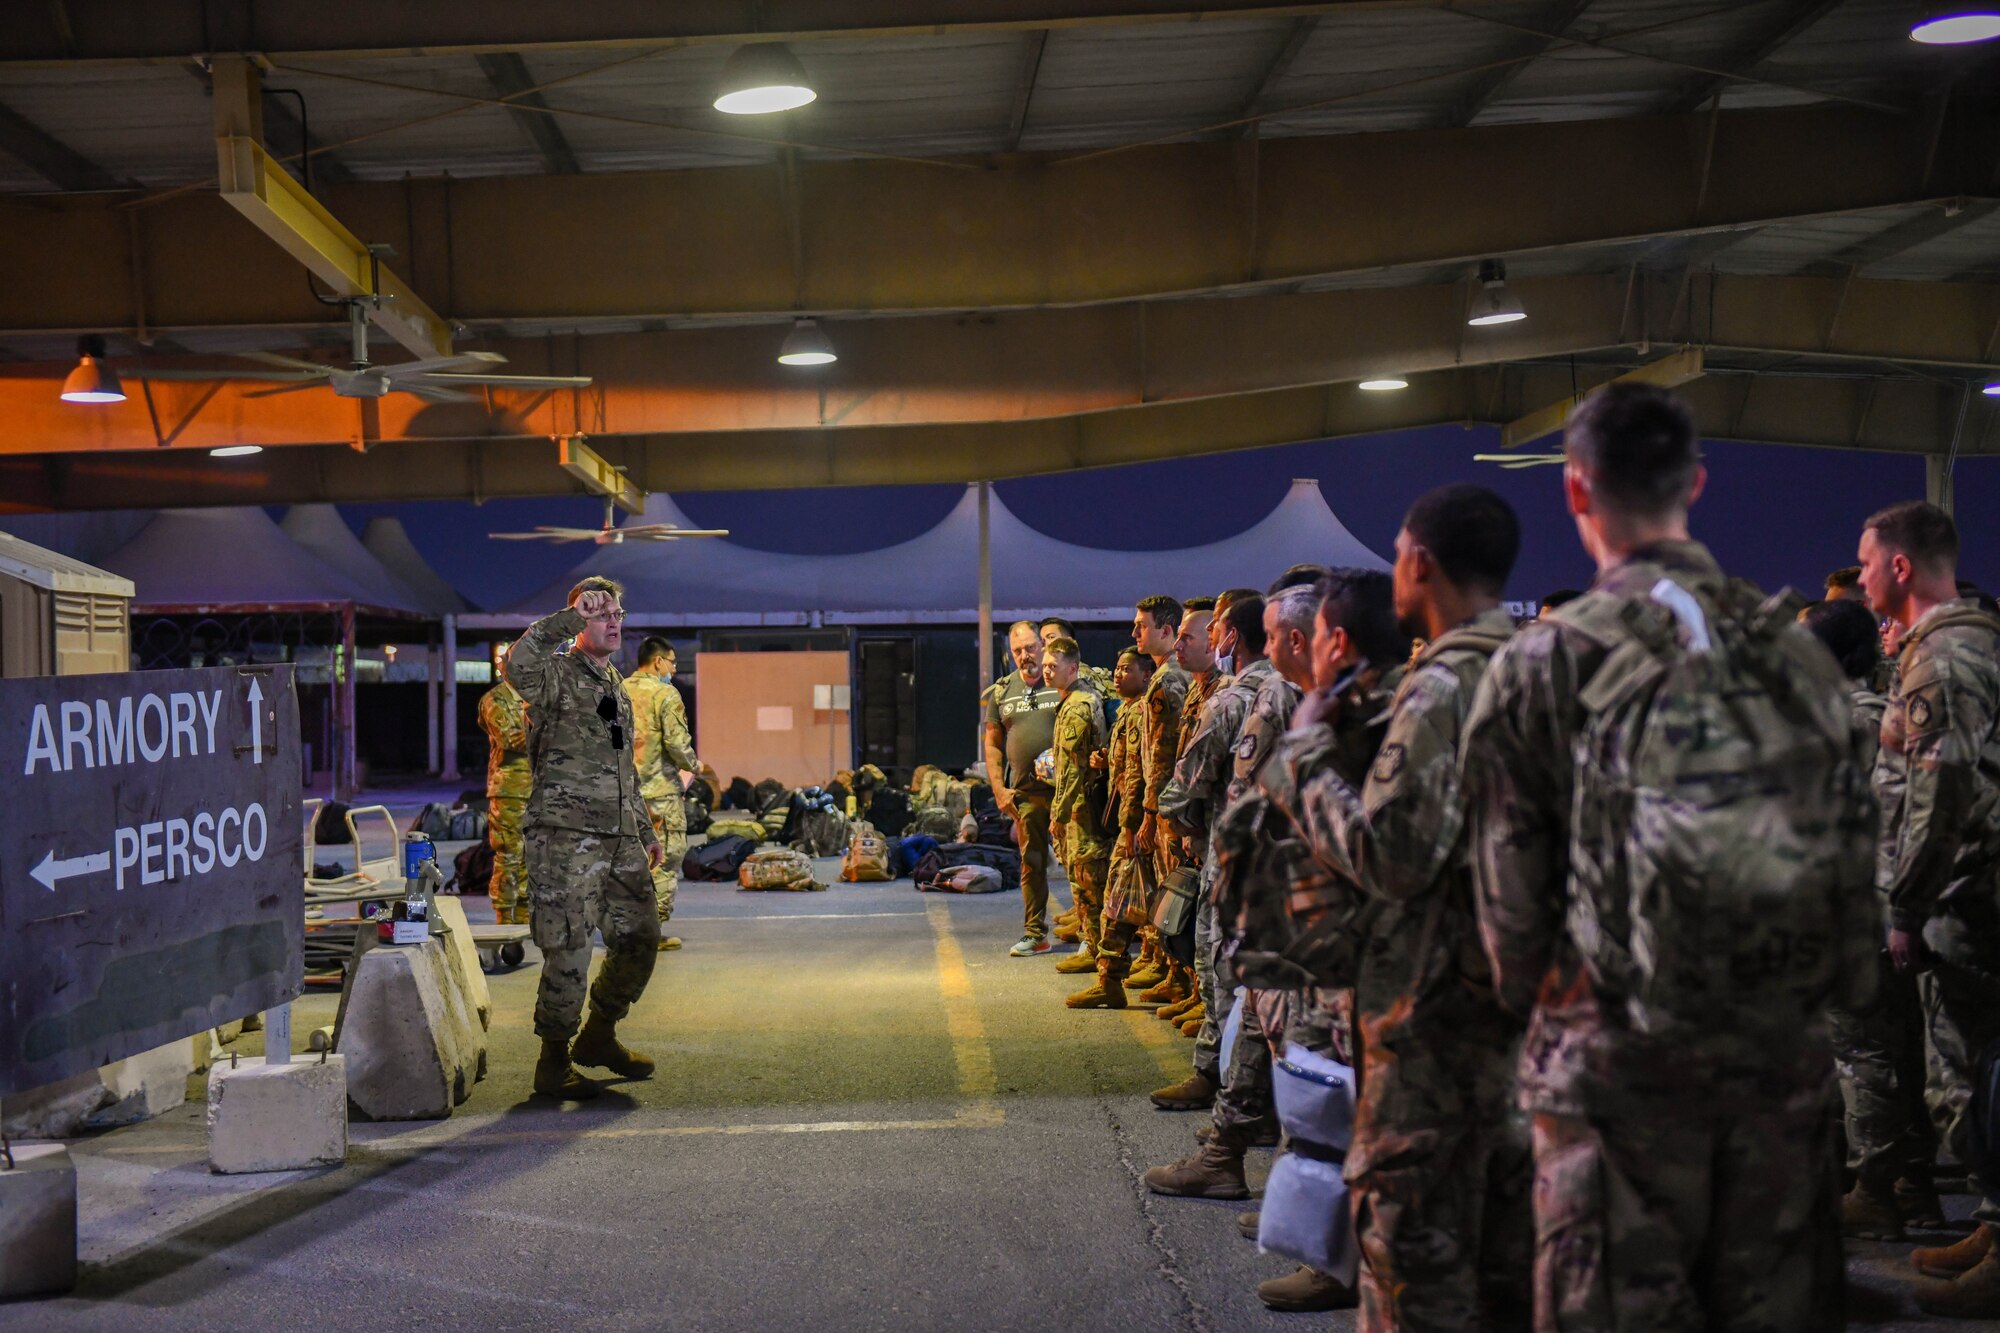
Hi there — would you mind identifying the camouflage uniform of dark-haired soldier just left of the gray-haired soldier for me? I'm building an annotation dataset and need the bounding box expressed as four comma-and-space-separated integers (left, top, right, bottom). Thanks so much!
1160, 656, 1276, 1085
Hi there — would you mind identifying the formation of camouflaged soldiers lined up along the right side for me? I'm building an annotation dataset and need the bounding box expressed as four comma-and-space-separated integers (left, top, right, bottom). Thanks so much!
1008, 384, 2000, 1331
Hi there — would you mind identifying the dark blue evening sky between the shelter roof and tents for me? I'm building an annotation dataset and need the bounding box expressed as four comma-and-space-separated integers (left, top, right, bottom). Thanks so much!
342, 426, 2000, 606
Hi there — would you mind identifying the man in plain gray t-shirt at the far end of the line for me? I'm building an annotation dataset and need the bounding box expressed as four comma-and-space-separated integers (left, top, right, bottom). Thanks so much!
980, 620, 1062, 959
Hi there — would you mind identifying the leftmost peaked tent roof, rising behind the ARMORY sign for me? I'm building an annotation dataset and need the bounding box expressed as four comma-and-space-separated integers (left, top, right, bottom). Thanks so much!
100, 506, 394, 610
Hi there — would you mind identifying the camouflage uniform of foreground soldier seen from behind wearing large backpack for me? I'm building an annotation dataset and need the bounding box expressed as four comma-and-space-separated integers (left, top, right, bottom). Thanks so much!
1460, 540, 1874, 1331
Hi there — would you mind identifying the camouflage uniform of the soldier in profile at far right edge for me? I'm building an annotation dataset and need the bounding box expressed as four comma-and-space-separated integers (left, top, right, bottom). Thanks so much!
1876, 600, 2000, 1223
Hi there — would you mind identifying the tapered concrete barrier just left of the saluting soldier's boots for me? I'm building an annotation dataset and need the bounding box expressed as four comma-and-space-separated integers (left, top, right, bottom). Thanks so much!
340, 941, 478, 1121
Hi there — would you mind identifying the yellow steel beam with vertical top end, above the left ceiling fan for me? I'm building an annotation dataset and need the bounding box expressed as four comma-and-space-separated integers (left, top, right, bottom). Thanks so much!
214, 56, 452, 356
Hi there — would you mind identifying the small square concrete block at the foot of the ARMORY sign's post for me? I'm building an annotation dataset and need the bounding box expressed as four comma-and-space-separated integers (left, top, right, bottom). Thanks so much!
208, 1055, 348, 1175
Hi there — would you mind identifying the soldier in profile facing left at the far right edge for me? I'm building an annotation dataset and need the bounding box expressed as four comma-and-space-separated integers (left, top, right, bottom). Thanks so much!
1860, 500, 2000, 1319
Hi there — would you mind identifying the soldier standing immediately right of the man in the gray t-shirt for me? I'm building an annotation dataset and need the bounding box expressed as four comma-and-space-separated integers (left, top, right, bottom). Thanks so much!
1042, 638, 1124, 980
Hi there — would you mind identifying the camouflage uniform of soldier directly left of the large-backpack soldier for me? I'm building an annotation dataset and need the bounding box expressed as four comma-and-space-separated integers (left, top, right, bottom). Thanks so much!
1300, 610, 1534, 1331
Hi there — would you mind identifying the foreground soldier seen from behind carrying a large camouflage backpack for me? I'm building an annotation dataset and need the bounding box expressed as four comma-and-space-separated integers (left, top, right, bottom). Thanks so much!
1460, 384, 1880, 1333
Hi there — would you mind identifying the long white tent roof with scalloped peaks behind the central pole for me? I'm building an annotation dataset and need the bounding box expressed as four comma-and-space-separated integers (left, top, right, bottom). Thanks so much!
480, 478, 1386, 626
